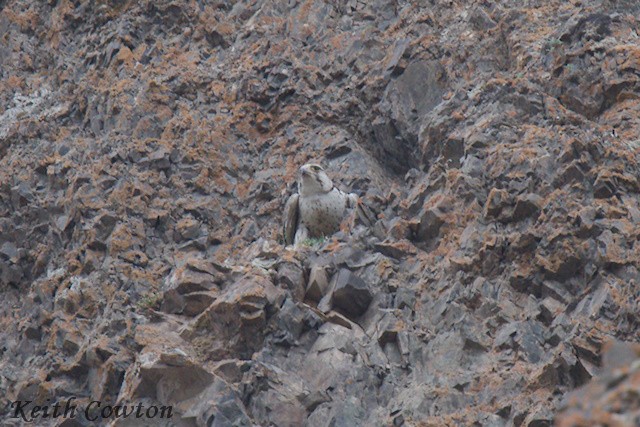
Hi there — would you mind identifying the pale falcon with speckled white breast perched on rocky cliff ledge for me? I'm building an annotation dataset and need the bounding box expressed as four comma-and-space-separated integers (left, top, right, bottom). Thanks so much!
283, 163, 358, 246
